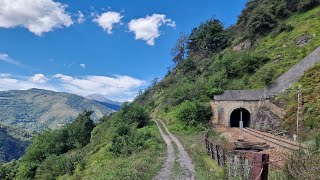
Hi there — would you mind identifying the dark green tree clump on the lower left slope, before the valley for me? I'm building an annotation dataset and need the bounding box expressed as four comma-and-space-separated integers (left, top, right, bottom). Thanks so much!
17, 112, 94, 179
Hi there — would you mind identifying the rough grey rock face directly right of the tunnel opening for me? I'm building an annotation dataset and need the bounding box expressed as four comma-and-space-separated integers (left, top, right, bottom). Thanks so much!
252, 108, 280, 131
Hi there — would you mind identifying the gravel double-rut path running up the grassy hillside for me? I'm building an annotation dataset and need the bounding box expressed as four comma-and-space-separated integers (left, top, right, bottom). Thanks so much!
156, 120, 195, 180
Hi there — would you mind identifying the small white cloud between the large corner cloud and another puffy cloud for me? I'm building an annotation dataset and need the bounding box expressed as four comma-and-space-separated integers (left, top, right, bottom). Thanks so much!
93, 11, 123, 34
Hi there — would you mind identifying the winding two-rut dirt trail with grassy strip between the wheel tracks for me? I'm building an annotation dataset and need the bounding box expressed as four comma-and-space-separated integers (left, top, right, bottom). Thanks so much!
154, 120, 195, 180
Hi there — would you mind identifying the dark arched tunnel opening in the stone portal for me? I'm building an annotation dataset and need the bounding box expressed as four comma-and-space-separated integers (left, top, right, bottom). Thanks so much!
230, 108, 250, 127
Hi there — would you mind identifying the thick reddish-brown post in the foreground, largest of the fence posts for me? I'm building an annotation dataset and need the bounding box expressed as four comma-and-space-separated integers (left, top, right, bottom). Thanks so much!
252, 153, 269, 180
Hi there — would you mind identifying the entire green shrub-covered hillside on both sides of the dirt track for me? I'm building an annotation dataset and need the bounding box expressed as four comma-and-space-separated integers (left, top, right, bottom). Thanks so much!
0, 0, 320, 179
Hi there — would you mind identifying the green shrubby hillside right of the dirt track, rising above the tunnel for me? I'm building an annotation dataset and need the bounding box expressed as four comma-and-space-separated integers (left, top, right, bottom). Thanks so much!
135, 0, 320, 179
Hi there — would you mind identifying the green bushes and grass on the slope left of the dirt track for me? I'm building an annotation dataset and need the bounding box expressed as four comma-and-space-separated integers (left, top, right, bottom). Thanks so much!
0, 104, 164, 179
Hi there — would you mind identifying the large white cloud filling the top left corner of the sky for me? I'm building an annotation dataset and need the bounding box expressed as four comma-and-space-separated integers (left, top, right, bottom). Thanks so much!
0, 0, 73, 36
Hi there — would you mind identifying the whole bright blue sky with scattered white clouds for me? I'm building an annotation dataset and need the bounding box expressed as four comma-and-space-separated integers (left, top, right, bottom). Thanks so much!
0, 0, 246, 101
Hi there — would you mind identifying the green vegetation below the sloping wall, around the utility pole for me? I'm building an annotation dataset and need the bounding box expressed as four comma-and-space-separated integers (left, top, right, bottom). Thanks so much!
276, 64, 320, 142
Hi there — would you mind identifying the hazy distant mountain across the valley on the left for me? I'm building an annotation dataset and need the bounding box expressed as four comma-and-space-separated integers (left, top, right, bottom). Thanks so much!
0, 89, 114, 131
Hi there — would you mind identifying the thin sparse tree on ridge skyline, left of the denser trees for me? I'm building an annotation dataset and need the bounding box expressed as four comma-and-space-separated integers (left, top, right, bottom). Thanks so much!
171, 33, 188, 64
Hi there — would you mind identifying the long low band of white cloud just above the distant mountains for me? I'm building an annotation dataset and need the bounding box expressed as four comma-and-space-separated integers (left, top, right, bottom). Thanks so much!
0, 74, 145, 102
